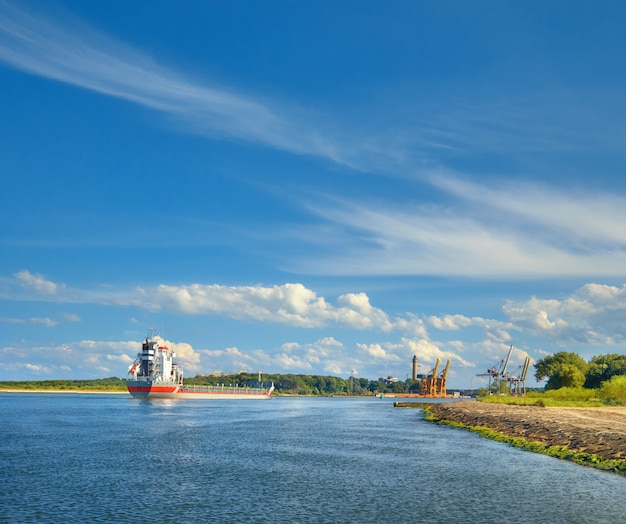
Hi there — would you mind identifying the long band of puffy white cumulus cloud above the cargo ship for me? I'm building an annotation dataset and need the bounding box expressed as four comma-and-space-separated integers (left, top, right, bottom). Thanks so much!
4, 271, 394, 331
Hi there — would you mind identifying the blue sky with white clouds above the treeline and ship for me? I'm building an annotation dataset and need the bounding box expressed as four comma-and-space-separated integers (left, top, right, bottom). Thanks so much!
0, 0, 626, 388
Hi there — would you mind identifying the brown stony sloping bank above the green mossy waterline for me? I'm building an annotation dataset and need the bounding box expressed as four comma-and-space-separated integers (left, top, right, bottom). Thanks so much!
431, 401, 626, 460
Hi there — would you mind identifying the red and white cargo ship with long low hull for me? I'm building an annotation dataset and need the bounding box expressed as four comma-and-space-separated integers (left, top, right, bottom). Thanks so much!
126, 336, 274, 399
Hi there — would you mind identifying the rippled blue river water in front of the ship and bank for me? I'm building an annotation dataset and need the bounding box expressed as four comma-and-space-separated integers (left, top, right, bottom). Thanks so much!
0, 393, 626, 524
